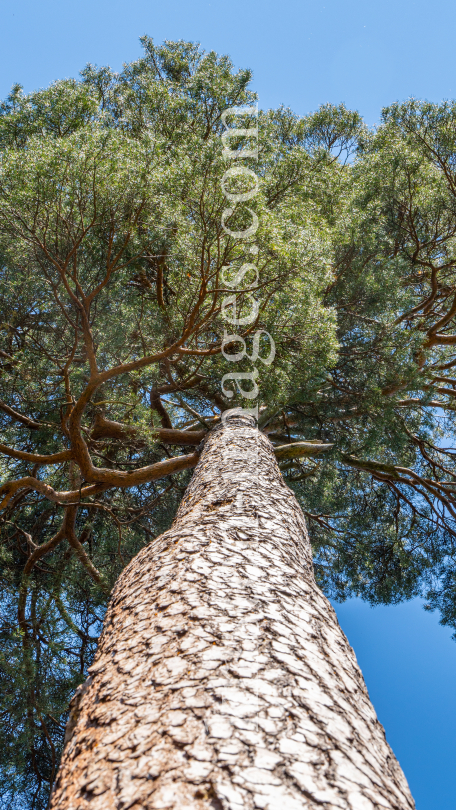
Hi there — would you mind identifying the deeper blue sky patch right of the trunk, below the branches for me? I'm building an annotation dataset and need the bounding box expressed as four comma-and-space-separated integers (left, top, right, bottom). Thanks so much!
334, 599, 456, 810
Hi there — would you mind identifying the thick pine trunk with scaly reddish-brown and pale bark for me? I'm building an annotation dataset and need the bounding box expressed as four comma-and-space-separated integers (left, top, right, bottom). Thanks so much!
51, 417, 414, 810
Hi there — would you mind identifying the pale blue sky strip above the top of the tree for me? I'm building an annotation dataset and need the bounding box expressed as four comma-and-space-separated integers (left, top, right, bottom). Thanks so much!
0, 0, 456, 123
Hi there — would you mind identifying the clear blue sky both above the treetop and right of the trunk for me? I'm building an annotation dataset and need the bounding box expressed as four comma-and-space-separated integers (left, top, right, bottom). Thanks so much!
0, 0, 456, 810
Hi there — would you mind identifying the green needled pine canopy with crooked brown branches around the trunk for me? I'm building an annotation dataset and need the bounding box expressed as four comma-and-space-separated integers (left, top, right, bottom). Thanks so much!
0, 37, 456, 808
